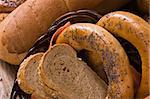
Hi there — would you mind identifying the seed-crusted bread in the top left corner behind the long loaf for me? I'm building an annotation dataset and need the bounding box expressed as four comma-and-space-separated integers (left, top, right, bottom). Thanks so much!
0, 0, 26, 12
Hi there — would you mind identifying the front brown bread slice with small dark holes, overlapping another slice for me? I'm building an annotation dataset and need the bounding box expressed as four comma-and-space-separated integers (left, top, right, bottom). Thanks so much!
39, 44, 107, 99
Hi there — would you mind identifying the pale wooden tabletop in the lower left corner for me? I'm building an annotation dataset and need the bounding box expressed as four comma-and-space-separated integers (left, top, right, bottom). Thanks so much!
0, 60, 17, 99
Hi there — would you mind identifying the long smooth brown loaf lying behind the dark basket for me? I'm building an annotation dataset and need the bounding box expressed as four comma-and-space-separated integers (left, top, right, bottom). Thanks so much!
0, 0, 131, 65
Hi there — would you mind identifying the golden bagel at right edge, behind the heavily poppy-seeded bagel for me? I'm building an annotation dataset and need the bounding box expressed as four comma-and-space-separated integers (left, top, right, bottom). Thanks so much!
97, 11, 150, 98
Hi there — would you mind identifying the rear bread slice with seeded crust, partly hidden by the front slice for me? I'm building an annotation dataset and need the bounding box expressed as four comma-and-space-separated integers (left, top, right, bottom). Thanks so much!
17, 53, 65, 99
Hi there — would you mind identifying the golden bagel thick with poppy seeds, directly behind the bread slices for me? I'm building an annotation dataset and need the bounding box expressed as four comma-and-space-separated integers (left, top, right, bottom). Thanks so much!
56, 23, 134, 99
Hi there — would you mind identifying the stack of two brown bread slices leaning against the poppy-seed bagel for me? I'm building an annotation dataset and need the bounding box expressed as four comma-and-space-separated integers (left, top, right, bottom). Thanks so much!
17, 44, 107, 99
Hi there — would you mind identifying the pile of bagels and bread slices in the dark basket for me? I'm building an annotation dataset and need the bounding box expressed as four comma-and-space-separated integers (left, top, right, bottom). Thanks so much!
17, 14, 150, 99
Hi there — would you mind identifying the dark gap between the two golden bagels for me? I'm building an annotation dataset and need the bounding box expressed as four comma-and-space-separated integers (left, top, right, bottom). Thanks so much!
116, 37, 142, 73
